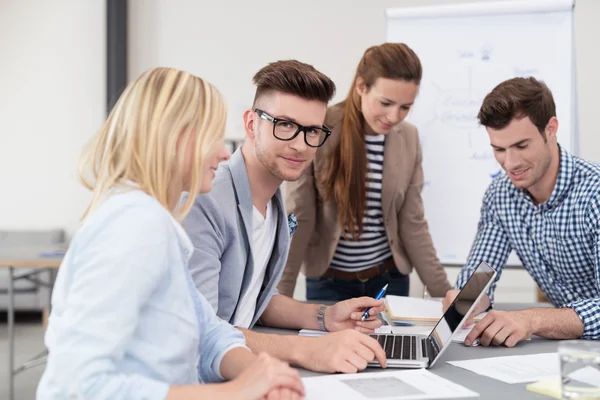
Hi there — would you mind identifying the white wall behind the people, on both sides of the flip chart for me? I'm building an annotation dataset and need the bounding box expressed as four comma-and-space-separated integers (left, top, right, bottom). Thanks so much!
0, 0, 600, 300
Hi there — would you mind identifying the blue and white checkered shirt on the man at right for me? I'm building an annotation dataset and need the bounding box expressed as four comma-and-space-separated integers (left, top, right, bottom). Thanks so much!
456, 148, 600, 339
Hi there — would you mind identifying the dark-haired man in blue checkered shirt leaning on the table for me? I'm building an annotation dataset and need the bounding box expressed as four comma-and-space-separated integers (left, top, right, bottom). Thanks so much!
444, 78, 600, 347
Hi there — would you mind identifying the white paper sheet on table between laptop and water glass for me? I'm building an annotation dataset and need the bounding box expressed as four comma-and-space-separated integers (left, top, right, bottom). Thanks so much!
447, 353, 560, 383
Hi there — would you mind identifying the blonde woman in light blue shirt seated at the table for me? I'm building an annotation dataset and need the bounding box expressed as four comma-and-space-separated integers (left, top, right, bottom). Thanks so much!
37, 68, 303, 400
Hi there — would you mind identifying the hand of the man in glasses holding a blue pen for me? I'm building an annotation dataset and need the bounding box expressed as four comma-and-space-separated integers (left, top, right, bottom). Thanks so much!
325, 296, 385, 333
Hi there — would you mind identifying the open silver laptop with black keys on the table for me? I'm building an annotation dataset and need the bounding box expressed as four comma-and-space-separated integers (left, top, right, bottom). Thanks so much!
369, 262, 496, 368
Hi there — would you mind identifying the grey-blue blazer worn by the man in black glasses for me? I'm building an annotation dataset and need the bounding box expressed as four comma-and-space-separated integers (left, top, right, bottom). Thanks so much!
183, 148, 290, 327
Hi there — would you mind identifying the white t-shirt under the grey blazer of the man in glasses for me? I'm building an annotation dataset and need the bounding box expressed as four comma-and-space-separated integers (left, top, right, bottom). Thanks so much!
234, 200, 277, 328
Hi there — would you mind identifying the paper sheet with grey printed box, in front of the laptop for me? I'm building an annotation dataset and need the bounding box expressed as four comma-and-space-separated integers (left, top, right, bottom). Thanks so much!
302, 369, 479, 400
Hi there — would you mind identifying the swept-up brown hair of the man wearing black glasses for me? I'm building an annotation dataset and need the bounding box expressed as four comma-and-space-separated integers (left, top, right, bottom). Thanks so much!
252, 60, 335, 105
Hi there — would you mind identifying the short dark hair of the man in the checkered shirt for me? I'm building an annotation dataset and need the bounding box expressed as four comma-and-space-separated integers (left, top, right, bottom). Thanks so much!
477, 77, 556, 135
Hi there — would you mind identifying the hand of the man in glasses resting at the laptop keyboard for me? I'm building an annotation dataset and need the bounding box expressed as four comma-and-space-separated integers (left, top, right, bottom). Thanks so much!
299, 329, 387, 373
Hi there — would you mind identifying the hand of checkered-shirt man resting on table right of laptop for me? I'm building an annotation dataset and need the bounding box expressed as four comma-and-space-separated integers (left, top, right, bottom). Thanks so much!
465, 310, 533, 347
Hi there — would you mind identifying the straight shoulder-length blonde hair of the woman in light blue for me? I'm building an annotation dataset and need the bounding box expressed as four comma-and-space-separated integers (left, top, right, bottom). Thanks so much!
79, 68, 226, 221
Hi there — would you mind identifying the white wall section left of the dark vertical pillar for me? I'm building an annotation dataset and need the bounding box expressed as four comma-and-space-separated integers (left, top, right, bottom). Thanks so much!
0, 0, 106, 231
